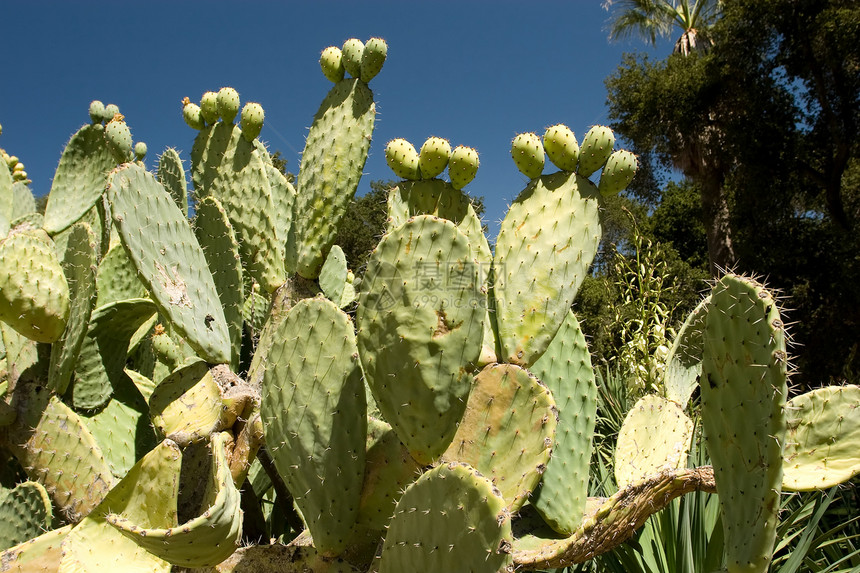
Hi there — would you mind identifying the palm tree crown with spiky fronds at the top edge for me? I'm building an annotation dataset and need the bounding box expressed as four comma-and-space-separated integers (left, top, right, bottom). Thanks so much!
603, 0, 722, 56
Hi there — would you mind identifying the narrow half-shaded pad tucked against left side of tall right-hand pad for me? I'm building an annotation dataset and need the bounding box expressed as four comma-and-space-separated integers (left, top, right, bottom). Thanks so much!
663, 297, 710, 409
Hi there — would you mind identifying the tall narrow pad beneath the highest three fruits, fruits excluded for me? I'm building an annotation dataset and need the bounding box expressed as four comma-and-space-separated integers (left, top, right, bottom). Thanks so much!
287, 79, 376, 279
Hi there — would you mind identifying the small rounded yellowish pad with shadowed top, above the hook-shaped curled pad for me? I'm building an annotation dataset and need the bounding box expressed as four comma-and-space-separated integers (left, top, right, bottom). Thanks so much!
149, 361, 236, 447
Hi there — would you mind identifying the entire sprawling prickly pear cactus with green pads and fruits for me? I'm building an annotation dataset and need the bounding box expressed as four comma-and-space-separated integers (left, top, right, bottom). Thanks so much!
0, 38, 860, 572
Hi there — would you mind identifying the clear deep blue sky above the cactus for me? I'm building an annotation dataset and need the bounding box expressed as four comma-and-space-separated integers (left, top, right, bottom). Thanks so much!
0, 0, 671, 237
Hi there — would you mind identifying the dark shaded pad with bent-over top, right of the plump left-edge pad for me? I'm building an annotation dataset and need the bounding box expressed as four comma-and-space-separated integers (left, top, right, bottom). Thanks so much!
67, 299, 156, 410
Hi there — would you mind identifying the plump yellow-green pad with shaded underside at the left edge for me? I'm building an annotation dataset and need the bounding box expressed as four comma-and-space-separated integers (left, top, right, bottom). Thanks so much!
0, 230, 70, 342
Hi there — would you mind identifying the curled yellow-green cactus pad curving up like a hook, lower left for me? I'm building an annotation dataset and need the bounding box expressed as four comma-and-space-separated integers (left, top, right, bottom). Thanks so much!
105, 434, 242, 567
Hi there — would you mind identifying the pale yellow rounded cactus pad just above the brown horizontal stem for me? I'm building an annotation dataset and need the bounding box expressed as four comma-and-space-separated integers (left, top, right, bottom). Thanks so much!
615, 395, 693, 489
